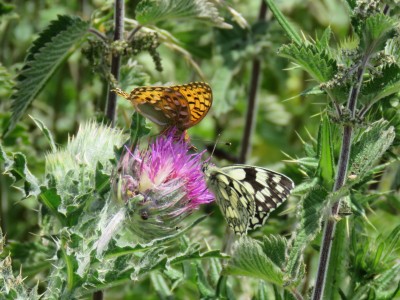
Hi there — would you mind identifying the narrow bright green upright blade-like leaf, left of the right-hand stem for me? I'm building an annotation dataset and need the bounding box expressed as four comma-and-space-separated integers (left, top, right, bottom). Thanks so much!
318, 117, 335, 190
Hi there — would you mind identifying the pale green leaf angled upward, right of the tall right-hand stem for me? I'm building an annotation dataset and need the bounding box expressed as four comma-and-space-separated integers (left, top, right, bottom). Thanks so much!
349, 120, 396, 184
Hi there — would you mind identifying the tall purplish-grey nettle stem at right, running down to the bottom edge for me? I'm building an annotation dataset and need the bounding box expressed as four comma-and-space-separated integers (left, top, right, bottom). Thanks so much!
312, 56, 371, 300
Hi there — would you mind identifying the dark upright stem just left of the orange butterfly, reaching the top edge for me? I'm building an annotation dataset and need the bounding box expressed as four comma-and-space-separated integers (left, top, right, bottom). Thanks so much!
106, 0, 124, 126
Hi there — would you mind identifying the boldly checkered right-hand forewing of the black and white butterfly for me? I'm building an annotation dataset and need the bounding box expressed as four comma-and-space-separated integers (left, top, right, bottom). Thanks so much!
221, 165, 294, 229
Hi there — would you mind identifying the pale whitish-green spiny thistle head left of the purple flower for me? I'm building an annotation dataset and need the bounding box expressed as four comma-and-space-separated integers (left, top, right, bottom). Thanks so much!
46, 122, 125, 205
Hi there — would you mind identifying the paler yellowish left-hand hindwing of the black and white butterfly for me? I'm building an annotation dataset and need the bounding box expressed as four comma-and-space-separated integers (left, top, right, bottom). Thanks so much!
205, 166, 255, 235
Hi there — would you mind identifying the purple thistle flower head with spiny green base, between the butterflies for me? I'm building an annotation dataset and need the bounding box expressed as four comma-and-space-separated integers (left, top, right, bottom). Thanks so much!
115, 130, 214, 238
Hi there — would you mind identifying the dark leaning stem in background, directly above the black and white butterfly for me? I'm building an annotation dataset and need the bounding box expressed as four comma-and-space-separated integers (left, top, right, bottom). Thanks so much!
239, 0, 267, 164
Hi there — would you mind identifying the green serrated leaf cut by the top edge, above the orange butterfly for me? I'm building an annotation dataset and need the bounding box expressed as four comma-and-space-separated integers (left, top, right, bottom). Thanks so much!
136, 0, 232, 29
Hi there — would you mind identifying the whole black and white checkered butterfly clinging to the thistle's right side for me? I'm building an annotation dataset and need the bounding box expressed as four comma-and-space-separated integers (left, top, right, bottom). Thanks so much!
203, 165, 294, 235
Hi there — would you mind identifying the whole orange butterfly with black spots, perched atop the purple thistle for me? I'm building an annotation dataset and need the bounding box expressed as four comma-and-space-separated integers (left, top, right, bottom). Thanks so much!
114, 82, 212, 132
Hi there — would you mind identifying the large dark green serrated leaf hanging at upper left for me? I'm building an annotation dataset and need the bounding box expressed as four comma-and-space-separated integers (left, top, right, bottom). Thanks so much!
5, 16, 89, 134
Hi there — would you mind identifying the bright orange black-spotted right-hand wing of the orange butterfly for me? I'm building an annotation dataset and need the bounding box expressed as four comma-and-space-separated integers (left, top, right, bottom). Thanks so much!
171, 82, 213, 129
